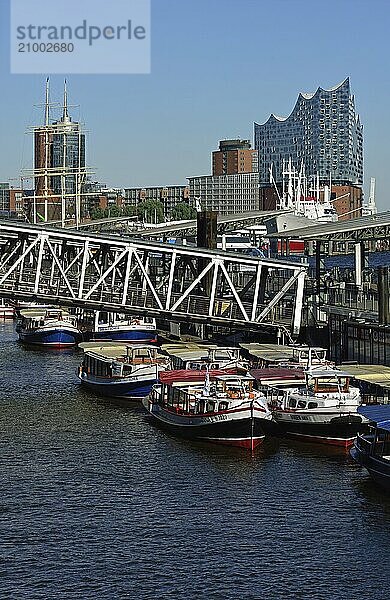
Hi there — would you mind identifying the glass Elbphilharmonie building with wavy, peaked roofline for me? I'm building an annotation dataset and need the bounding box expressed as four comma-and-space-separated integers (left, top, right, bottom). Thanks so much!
255, 78, 363, 187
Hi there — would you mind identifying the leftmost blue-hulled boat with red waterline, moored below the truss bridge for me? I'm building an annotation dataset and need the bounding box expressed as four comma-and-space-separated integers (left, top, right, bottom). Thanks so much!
16, 307, 82, 348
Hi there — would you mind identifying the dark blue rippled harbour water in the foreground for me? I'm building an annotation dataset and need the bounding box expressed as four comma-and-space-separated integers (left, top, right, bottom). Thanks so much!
0, 324, 390, 600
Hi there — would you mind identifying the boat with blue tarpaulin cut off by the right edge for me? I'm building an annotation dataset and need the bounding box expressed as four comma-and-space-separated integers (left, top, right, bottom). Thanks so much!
350, 404, 390, 491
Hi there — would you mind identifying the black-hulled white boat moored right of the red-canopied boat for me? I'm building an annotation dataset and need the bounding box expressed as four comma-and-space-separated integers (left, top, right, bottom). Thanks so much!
267, 369, 368, 448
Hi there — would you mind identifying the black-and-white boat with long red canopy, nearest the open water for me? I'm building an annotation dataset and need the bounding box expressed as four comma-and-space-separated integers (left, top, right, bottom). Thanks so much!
143, 370, 272, 450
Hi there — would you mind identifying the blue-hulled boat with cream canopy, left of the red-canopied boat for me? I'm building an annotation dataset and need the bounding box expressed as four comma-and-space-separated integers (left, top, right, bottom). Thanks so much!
79, 342, 168, 400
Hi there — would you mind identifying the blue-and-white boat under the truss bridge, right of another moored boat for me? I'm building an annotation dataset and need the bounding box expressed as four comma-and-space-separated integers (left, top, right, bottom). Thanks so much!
92, 311, 157, 344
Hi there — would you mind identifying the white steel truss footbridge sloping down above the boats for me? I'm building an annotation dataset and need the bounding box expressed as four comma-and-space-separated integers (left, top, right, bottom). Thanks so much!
0, 221, 306, 336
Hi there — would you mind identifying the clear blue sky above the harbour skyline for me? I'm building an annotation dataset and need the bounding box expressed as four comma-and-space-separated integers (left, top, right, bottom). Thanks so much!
0, 0, 390, 210
